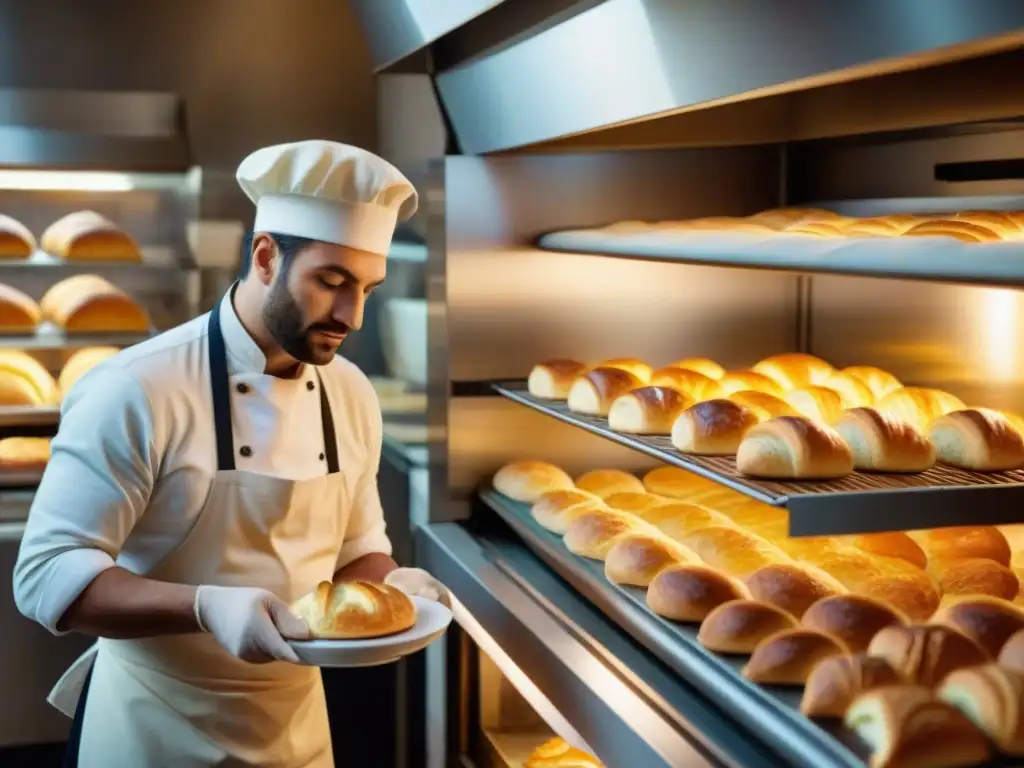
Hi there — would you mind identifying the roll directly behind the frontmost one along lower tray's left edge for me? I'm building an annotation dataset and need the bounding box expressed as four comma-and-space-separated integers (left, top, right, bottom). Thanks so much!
800, 653, 902, 719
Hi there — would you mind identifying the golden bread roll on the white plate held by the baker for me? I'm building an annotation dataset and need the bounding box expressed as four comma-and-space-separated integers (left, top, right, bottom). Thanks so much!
292, 582, 416, 639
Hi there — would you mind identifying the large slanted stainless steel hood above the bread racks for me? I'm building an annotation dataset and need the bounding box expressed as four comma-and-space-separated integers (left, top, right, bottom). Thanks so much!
437, 0, 1024, 154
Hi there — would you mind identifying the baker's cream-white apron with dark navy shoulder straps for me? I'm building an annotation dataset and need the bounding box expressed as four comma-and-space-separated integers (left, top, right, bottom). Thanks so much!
50, 290, 349, 768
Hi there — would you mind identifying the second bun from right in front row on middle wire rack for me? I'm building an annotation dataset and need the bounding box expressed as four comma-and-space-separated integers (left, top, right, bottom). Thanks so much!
835, 408, 935, 472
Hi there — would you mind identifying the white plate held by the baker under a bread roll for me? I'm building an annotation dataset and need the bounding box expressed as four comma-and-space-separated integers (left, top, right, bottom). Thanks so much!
288, 597, 452, 667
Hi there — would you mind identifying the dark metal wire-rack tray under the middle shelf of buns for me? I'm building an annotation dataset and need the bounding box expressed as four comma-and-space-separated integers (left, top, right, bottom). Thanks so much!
492, 381, 1024, 537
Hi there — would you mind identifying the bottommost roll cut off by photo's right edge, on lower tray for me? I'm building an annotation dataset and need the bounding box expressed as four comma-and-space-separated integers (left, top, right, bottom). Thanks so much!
935, 664, 1024, 757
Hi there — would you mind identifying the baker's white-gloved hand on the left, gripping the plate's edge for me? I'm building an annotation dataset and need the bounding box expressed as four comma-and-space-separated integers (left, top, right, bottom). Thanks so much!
195, 585, 310, 664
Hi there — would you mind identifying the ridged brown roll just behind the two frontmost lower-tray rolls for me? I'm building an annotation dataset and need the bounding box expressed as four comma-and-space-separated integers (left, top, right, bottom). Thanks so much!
867, 624, 990, 688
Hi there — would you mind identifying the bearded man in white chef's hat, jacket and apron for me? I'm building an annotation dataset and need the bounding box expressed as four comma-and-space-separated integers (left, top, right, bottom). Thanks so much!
14, 141, 446, 768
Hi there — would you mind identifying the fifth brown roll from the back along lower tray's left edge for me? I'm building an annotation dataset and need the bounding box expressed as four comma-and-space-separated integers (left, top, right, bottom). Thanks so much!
647, 563, 751, 624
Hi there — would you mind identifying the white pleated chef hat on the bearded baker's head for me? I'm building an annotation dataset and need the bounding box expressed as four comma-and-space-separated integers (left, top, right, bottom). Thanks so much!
236, 140, 417, 256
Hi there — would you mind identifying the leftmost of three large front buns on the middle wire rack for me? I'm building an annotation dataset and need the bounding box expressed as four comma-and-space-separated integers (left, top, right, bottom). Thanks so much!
736, 416, 853, 480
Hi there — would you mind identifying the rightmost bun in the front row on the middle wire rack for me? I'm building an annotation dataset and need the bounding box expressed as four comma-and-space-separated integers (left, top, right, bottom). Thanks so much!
931, 408, 1024, 472
